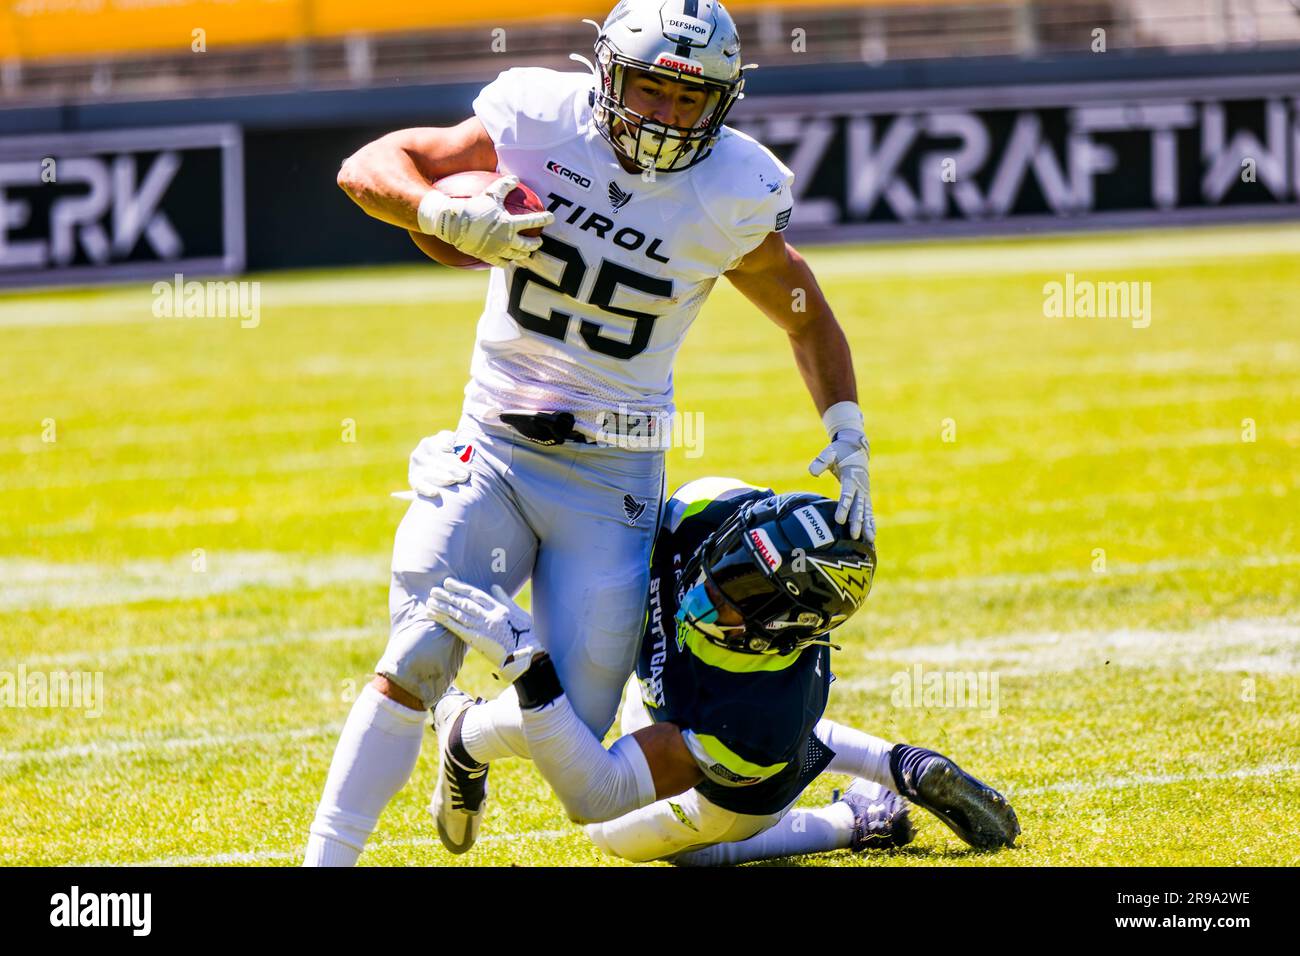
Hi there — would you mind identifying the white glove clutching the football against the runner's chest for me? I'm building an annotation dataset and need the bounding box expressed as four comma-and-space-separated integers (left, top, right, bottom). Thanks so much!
417, 176, 555, 267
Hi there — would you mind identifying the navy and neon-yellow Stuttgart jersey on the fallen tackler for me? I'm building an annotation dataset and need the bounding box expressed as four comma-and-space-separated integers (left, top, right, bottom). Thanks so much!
637, 477, 832, 814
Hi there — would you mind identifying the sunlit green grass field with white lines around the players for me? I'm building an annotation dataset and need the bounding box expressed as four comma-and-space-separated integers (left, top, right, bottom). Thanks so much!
0, 226, 1300, 866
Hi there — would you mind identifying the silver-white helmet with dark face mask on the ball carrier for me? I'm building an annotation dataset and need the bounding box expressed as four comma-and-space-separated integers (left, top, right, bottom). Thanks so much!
585, 0, 745, 173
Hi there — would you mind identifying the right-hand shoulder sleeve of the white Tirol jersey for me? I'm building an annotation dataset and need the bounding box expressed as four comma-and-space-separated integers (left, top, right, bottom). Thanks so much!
698, 126, 794, 268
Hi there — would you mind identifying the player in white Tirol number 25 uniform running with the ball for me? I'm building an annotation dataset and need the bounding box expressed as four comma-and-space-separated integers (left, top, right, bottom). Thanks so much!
304, 0, 875, 865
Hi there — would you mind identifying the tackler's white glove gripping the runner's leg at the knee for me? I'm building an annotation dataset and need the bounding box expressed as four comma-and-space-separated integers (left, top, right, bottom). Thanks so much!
428, 578, 538, 684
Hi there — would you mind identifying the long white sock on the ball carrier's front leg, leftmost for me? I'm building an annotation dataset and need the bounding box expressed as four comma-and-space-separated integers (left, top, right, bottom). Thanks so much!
303, 684, 425, 866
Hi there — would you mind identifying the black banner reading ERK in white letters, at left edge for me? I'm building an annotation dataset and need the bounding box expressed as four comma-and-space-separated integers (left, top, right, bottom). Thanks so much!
0, 125, 244, 285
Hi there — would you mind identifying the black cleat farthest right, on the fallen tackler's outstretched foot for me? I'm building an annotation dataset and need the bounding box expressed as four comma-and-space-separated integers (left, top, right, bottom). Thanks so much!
889, 744, 1021, 849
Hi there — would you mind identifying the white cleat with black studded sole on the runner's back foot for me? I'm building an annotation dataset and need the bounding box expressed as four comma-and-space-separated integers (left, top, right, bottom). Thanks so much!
429, 687, 488, 853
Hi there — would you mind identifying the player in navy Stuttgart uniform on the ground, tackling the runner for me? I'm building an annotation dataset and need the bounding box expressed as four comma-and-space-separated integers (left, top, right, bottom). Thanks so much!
429, 479, 1019, 865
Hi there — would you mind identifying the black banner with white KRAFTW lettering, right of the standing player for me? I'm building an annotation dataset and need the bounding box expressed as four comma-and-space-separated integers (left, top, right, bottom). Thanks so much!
732, 74, 1300, 239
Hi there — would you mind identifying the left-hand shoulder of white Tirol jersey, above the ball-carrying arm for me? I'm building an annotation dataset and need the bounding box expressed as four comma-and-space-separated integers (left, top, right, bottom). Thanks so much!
473, 66, 592, 147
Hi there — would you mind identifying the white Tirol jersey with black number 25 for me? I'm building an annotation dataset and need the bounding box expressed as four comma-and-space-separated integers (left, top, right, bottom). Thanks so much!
464, 68, 794, 447
